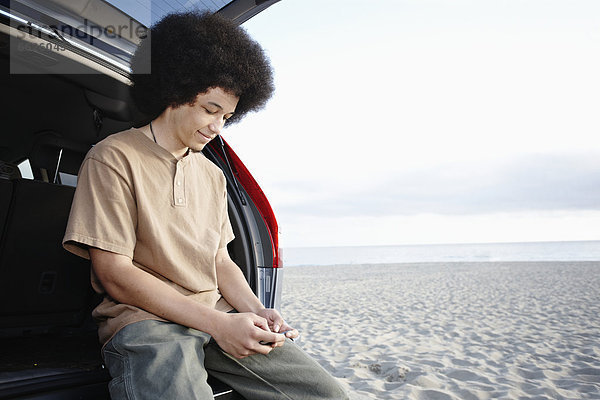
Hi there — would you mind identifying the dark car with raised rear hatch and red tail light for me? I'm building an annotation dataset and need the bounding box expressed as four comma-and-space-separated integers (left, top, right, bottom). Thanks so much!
0, 0, 282, 399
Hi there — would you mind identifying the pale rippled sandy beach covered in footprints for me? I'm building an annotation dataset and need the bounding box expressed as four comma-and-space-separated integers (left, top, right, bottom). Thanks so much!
282, 262, 600, 400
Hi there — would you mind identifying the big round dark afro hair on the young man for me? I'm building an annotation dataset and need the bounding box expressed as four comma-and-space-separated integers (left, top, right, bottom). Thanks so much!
131, 12, 274, 124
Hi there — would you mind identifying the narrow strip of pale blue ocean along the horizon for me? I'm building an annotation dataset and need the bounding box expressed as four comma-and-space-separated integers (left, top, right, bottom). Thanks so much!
283, 241, 600, 266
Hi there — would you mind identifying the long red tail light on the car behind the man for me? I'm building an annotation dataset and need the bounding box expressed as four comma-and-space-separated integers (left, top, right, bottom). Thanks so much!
210, 140, 283, 268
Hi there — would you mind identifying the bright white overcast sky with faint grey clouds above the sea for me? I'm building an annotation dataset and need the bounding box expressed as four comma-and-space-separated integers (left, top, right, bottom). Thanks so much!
223, 0, 600, 247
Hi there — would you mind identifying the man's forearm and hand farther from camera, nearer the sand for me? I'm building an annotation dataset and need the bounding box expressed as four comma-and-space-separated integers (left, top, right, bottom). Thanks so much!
215, 247, 298, 340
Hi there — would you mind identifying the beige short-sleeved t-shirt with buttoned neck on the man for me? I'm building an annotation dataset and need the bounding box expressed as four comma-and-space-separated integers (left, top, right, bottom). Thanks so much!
63, 129, 234, 343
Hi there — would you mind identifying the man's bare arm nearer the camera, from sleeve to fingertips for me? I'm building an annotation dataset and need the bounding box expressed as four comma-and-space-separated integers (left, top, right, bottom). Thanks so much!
90, 248, 281, 358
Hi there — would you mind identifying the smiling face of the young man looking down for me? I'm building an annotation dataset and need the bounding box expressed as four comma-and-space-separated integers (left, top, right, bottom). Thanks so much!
171, 87, 239, 151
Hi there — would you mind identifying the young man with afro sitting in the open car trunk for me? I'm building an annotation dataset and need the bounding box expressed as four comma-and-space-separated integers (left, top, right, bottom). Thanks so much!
64, 13, 347, 400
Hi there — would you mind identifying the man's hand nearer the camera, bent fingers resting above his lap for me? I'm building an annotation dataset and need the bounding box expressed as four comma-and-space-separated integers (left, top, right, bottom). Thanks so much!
212, 313, 285, 358
